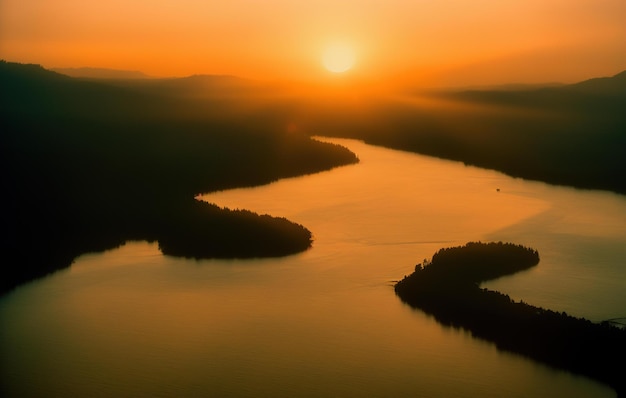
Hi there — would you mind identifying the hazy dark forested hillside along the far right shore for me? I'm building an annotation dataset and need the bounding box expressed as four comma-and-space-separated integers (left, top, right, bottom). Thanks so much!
296, 72, 626, 194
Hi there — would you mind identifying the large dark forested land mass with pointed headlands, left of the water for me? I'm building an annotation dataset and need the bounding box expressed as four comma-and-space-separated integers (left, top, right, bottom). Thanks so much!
0, 61, 358, 294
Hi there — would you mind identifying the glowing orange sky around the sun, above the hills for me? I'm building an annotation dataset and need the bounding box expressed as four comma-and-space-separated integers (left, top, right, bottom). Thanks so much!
0, 0, 626, 85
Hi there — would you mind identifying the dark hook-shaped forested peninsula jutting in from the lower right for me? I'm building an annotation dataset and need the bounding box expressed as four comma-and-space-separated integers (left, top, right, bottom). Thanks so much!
395, 242, 626, 397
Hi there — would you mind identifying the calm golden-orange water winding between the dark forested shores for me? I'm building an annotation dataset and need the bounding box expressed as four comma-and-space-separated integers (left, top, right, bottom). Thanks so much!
0, 139, 626, 397
